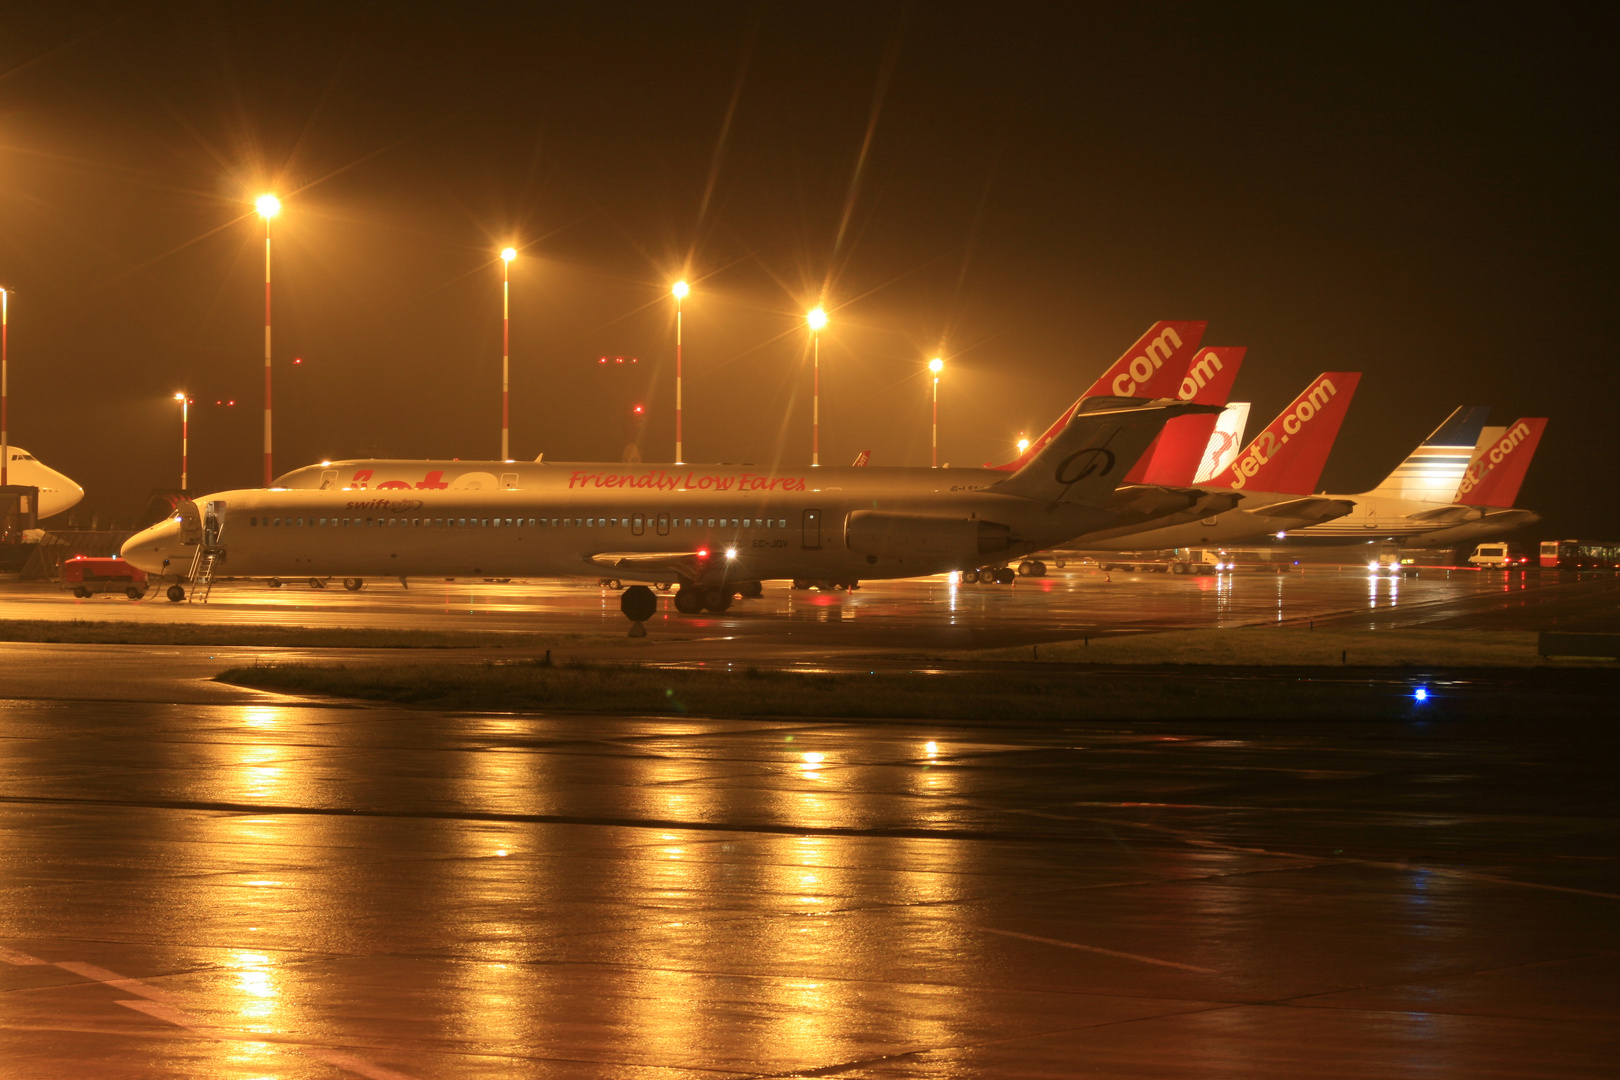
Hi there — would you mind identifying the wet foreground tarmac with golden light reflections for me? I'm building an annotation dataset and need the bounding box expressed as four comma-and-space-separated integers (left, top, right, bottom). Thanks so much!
0, 698, 1620, 1078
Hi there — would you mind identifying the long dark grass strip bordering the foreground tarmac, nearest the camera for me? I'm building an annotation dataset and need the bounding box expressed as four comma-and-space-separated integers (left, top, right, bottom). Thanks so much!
217, 661, 1614, 722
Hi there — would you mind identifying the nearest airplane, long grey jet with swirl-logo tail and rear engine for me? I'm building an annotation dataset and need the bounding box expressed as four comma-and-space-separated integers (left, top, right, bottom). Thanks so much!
122, 397, 1220, 614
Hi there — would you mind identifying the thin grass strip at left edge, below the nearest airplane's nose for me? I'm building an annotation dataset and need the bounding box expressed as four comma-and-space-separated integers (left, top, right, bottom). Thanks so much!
0, 619, 596, 649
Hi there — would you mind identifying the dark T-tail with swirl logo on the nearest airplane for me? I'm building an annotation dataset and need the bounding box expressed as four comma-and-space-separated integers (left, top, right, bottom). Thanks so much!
988, 397, 1220, 507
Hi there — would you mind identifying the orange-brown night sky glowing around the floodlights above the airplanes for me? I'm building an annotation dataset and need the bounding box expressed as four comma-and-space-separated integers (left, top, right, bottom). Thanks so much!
0, 3, 1620, 539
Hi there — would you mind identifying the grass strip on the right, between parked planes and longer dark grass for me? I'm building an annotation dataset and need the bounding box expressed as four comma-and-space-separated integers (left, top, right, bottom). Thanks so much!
936, 627, 1615, 667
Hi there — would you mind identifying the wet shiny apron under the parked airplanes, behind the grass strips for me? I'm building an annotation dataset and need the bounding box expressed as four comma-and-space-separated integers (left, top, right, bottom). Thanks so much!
0, 567, 1620, 661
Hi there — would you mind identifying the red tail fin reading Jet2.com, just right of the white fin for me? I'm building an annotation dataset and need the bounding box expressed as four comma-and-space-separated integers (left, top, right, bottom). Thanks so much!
1209, 371, 1361, 495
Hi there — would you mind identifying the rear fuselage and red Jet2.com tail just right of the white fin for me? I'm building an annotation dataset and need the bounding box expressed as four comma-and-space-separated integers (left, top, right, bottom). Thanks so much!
1066, 371, 1361, 551
